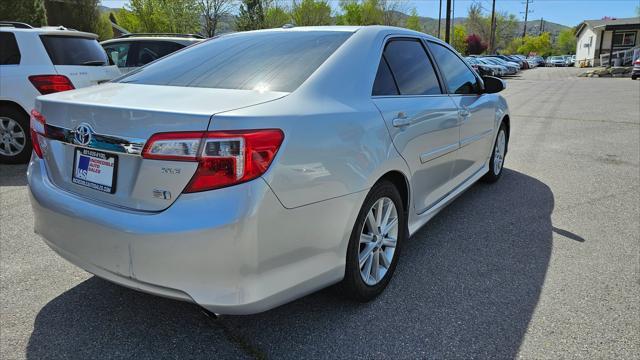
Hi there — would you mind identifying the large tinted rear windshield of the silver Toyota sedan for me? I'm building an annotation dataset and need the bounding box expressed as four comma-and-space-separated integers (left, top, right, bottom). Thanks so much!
120, 31, 351, 92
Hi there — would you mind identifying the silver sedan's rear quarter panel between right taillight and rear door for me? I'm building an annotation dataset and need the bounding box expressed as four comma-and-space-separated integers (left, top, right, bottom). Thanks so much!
210, 93, 408, 208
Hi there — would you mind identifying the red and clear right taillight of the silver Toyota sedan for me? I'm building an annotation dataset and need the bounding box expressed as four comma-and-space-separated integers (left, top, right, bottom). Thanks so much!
142, 129, 284, 193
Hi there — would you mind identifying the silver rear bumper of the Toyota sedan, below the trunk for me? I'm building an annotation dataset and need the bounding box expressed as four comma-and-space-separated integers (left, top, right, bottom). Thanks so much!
28, 159, 366, 314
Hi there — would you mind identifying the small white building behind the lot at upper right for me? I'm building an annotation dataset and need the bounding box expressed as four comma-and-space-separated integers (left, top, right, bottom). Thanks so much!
576, 17, 640, 66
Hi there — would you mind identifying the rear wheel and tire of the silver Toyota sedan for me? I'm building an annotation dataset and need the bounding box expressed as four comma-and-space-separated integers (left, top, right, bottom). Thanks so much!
340, 180, 408, 302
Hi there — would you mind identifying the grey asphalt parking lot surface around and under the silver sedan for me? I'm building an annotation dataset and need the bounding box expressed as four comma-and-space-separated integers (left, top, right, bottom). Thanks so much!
0, 68, 640, 359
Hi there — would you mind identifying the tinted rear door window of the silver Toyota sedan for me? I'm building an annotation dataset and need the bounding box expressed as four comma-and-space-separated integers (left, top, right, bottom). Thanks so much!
383, 39, 442, 95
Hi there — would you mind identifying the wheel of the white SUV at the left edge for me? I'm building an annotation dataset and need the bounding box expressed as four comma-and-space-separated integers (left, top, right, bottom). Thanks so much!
0, 105, 32, 164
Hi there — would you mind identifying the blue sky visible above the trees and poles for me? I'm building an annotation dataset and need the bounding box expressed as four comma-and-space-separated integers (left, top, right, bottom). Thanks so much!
102, 0, 640, 26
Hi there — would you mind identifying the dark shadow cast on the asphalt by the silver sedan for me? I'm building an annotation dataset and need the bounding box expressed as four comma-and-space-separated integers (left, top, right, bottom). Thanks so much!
27, 169, 554, 359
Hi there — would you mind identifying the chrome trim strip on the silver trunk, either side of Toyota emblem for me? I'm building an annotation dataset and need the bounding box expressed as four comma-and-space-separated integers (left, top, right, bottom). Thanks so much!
45, 124, 147, 155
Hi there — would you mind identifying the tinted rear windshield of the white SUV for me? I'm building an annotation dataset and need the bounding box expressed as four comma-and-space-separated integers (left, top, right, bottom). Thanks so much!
40, 35, 109, 66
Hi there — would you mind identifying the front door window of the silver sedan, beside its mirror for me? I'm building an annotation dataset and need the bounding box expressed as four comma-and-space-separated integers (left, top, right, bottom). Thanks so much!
429, 42, 479, 94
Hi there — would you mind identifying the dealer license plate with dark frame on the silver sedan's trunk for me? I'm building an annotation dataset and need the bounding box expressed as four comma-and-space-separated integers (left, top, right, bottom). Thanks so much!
71, 147, 118, 194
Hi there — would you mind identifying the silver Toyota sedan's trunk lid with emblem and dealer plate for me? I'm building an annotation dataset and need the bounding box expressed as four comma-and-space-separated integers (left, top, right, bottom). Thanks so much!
36, 83, 286, 211
